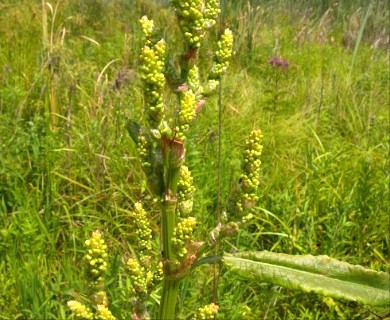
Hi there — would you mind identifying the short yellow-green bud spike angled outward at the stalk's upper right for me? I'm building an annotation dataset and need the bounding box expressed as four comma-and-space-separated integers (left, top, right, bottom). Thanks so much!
211, 29, 233, 79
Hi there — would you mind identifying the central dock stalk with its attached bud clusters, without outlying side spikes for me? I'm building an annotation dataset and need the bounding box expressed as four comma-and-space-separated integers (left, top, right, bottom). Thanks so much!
135, 0, 233, 318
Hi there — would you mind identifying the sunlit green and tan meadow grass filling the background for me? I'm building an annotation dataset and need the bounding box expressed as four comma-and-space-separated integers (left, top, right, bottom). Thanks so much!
0, 0, 390, 319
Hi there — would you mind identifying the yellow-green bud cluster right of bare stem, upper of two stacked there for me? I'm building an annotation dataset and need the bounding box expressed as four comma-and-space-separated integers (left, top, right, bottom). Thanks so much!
177, 165, 196, 217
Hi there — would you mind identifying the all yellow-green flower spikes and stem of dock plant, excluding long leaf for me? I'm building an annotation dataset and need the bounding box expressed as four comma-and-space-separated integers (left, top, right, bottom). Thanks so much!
68, 0, 261, 320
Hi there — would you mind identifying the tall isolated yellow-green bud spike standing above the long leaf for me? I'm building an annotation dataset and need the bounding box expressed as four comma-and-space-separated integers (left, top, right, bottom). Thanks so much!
237, 129, 263, 220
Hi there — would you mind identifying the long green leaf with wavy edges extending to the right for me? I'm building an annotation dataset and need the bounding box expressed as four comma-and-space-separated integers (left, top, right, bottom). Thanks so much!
222, 251, 390, 307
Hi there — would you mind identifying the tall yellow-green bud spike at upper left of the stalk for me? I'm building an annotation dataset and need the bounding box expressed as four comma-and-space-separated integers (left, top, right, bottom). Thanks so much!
140, 16, 165, 126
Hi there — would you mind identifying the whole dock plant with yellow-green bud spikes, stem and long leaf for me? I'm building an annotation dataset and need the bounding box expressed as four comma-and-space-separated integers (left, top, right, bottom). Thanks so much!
68, 0, 389, 319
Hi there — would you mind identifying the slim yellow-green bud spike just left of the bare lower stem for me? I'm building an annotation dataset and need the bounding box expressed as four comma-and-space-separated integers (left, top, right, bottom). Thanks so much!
134, 202, 152, 255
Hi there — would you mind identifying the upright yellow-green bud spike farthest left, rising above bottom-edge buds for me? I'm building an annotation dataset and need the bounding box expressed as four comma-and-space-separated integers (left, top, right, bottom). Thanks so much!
85, 230, 107, 288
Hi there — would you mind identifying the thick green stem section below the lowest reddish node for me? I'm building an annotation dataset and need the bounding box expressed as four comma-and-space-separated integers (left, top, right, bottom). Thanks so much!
158, 278, 180, 320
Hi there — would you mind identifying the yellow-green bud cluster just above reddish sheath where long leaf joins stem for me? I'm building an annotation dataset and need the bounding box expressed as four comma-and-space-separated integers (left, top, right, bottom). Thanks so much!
172, 217, 196, 258
